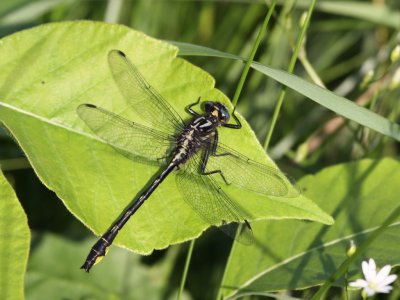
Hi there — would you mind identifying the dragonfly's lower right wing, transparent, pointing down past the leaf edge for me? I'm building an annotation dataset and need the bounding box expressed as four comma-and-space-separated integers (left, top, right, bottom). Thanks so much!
176, 156, 253, 244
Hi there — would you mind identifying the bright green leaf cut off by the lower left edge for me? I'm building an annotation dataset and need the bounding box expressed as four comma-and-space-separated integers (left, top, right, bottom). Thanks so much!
0, 171, 30, 299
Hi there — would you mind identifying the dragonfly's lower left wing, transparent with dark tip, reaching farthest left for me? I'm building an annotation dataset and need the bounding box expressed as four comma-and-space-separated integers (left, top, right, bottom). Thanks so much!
77, 104, 175, 164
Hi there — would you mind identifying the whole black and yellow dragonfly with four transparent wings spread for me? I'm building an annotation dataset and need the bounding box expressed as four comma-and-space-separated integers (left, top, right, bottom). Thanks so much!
77, 50, 293, 272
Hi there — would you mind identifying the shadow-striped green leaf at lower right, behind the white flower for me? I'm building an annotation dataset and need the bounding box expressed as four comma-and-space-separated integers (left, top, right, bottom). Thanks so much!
222, 158, 400, 296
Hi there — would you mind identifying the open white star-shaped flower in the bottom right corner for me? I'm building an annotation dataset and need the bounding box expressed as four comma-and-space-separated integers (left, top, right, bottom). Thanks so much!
349, 258, 397, 297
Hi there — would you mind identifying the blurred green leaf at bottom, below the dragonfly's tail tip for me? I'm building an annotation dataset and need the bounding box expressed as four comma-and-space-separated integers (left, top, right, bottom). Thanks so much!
25, 233, 178, 300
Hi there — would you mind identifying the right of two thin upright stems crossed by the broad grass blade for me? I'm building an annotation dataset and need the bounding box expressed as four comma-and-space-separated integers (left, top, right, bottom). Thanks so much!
264, 0, 317, 150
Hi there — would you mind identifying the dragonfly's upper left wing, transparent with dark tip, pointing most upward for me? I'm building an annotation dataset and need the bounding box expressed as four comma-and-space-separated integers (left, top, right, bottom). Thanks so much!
108, 50, 184, 133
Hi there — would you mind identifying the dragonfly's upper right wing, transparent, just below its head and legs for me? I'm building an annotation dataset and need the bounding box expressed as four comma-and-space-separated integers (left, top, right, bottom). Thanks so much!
206, 143, 300, 197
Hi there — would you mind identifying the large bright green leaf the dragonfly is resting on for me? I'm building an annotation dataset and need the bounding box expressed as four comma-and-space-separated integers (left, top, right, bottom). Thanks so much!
0, 22, 332, 253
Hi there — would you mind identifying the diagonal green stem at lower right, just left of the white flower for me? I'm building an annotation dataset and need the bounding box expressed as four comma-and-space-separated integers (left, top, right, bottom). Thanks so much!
311, 206, 400, 300
